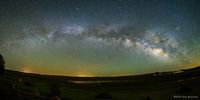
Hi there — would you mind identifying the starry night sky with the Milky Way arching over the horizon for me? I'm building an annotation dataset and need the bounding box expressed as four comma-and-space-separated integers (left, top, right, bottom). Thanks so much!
0, 0, 200, 76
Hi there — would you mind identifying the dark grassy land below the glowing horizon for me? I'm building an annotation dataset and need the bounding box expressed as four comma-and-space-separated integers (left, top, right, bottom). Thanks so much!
0, 67, 200, 100
